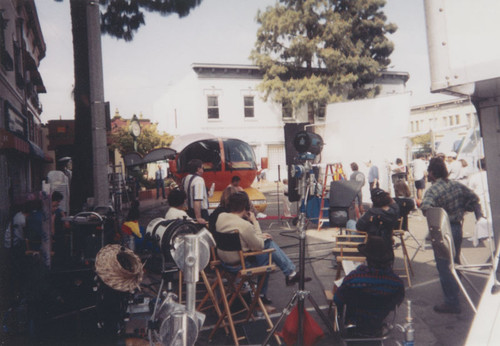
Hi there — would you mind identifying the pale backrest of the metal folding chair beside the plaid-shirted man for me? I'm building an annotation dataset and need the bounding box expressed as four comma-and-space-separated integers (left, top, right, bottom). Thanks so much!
425, 207, 455, 259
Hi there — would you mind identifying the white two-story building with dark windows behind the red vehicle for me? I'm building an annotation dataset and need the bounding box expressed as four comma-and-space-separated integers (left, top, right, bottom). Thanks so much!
154, 63, 409, 181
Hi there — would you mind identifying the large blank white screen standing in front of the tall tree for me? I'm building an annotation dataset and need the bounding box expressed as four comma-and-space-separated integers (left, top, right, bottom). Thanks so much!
321, 94, 410, 201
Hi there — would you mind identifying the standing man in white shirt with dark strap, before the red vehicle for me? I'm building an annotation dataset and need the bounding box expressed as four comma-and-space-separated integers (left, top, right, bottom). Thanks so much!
182, 159, 208, 225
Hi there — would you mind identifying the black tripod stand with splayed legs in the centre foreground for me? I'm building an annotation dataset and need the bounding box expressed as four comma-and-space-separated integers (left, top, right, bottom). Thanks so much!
262, 165, 335, 345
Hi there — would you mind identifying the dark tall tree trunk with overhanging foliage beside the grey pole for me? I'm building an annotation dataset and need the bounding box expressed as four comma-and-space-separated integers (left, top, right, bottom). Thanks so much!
62, 0, 201, 212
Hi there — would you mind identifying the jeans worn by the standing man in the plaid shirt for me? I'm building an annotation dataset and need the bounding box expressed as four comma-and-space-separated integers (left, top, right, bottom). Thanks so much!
434, 223, 462, 307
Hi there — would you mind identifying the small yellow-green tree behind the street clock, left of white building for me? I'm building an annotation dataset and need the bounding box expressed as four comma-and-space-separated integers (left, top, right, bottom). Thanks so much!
110, 124, 174, 156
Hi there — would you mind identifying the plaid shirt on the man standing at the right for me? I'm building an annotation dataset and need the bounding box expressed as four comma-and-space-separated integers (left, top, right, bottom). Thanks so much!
420, 179, 479, 223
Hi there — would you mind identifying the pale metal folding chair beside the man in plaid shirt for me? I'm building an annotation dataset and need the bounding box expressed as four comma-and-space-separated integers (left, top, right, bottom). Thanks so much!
425, 208, 493, 313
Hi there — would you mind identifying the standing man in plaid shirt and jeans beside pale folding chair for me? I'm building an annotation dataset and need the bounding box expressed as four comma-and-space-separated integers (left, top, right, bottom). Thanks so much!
420, 158, 483, 314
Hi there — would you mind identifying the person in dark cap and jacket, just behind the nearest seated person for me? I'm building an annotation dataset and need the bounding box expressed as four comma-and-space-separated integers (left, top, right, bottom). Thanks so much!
356, 188, 399, 252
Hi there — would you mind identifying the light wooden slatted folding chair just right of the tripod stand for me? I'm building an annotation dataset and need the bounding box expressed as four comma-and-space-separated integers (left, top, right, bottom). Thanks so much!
325, 229, 367, 314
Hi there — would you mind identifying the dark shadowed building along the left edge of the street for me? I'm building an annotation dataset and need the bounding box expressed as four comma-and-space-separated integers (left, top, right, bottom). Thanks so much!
0, 0, 47, 225
